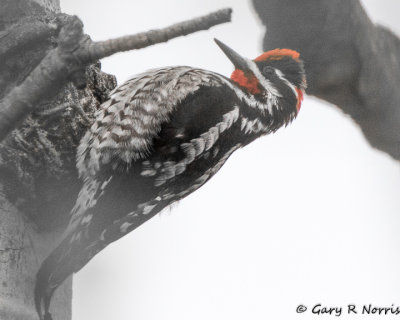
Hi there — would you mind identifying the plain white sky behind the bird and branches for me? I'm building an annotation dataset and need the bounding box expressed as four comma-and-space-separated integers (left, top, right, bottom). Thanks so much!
61, 0, 400, 320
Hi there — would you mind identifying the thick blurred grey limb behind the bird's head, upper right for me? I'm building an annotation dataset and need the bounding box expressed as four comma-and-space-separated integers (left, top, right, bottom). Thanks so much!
253, 0, 400, 160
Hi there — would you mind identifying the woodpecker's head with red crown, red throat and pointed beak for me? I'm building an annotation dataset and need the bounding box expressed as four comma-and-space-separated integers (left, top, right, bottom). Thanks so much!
215, 39, 306, 116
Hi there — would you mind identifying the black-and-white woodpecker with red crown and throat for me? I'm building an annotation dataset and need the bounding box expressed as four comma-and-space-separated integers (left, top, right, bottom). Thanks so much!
34, 39, 307, 320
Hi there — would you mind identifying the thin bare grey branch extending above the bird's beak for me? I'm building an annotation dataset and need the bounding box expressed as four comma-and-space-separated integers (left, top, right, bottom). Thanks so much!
0, 9, 232, 141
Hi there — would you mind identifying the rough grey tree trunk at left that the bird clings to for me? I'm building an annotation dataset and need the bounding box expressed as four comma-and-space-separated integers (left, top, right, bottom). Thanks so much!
0, 0, 116, 320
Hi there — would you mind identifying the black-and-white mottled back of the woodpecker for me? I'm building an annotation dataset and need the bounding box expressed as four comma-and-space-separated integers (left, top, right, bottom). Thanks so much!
65, 67, 226, 235
